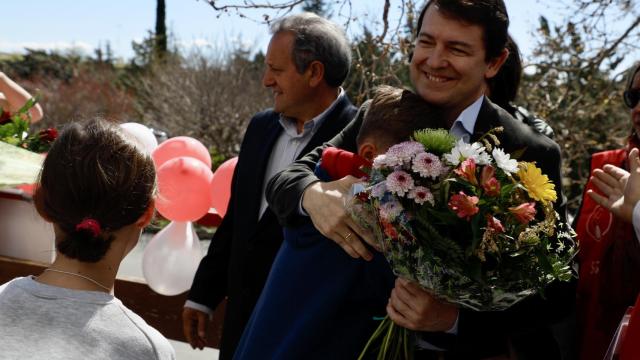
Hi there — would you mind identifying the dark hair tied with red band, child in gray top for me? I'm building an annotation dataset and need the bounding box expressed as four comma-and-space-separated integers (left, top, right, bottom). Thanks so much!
34, 119, 155, 262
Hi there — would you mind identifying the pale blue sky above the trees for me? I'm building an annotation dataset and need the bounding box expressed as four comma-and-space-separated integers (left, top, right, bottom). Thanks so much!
0, 0, 568, 62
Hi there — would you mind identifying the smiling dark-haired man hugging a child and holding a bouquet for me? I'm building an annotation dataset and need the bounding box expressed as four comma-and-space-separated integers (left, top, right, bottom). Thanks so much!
267, 0, 575, 359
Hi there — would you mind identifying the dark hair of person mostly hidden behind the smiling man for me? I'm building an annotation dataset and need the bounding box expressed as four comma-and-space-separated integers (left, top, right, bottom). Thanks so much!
487, 36, 522, 109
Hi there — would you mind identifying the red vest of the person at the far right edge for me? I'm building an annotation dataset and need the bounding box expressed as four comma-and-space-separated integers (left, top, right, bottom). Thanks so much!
576, 149, 640, 360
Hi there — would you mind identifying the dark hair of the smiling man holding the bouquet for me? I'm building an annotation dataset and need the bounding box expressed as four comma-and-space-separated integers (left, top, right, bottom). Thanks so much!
416, 0, 509, 61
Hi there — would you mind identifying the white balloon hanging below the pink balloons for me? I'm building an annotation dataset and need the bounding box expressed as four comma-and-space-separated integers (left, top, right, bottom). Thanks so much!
142, 221, 202, 296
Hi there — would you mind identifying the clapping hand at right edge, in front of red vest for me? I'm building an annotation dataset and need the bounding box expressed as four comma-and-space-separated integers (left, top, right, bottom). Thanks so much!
587, 149, 640, 222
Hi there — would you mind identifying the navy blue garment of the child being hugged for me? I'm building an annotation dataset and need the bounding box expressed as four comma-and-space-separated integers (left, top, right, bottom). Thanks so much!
234, 165, 395, 360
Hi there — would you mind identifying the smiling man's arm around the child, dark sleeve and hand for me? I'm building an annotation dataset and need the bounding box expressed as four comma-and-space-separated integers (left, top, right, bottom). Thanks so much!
266, 105, 373, 260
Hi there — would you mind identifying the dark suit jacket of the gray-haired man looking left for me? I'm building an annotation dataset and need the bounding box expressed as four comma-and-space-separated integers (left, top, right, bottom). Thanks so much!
188, 96, 357, 360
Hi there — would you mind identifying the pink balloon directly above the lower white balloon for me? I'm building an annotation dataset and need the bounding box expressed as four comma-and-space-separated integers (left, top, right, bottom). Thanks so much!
156, 157, 213, 221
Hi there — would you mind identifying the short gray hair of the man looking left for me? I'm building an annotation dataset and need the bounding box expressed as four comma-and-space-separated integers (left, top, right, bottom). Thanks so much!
271, 12, 351, 87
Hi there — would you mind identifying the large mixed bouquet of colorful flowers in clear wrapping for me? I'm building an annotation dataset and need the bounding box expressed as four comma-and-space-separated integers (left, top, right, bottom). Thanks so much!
349, 128, 576, 358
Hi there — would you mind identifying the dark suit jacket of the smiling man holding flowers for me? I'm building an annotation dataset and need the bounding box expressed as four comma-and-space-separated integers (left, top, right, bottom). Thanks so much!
266, 97, 575, 359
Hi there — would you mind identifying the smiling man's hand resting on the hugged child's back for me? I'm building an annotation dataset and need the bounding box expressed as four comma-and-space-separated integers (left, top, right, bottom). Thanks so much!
302, 176, 377, 260
